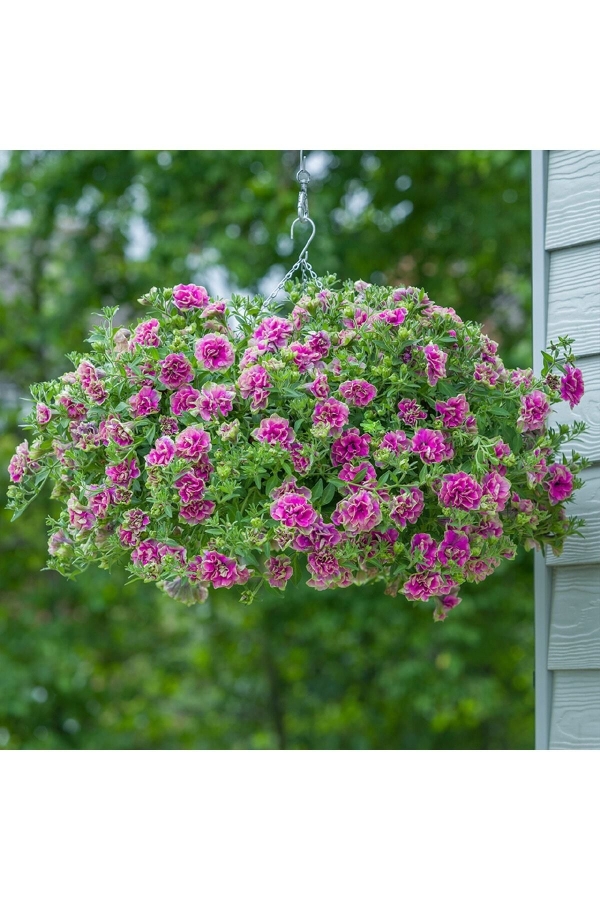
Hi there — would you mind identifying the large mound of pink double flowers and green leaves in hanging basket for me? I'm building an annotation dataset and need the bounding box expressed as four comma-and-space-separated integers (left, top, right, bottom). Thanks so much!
9, 276, 585, 620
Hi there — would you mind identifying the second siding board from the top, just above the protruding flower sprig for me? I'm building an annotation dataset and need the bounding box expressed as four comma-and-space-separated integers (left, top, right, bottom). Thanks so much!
548, 242, 600, 357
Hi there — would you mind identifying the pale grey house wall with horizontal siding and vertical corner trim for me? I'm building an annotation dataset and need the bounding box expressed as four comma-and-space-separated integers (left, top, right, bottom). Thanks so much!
532, 150, 600, 750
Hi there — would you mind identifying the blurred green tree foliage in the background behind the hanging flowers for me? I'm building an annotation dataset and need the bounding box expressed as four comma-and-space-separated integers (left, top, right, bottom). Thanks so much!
0, 151, 533, 749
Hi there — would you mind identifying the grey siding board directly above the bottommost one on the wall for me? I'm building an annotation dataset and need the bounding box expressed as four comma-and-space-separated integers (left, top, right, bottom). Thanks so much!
548, 565, 600, 669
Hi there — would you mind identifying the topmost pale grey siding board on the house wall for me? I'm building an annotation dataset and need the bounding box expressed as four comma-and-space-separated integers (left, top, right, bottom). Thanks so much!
546, 150, 600, 250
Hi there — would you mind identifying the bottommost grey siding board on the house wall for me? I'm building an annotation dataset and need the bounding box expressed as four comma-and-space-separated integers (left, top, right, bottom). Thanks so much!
550, 669, 600, 750
